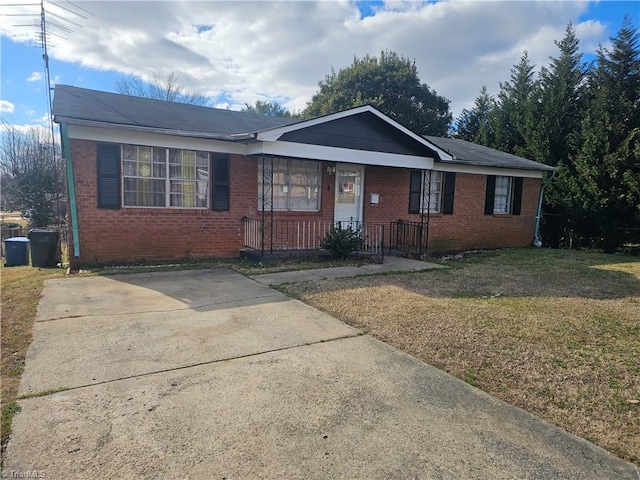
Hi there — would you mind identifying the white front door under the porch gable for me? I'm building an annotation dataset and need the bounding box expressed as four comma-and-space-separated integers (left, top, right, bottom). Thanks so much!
333, 163, 364, 222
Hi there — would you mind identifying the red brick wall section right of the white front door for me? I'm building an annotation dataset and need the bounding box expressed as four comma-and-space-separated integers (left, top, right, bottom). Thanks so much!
364, 167, 540, 252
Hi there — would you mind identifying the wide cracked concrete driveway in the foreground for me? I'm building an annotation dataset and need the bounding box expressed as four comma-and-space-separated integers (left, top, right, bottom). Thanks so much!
4, 269, 640, 480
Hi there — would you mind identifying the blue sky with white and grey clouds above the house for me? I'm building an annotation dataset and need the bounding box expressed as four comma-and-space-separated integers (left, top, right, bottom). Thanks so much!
0, 0, 640, 133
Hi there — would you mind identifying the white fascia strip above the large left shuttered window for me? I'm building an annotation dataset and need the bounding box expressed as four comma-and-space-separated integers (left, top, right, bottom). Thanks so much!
68, 125, 244, 155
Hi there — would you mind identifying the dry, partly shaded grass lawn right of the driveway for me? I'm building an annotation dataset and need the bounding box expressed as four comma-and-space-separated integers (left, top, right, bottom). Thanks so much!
284, 249, 640, 464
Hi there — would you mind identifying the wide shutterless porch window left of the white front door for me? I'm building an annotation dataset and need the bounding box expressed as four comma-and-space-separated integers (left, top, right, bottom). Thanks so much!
258, 158, 320, 211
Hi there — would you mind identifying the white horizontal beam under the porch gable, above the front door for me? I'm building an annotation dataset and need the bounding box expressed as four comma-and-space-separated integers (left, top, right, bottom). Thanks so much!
244, 142, 434, 170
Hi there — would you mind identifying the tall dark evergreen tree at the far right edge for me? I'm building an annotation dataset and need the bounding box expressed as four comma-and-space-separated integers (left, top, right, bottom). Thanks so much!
564, 16, 640, 250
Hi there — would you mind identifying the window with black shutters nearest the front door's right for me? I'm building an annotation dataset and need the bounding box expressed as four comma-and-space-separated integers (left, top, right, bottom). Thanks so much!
409, 170, 456, 215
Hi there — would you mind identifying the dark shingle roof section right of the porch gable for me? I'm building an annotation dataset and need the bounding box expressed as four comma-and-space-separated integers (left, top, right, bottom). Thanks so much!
424, 136, 555, 171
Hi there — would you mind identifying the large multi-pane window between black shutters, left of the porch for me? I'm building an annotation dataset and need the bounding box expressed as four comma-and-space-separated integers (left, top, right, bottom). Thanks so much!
122, 145, 209, 208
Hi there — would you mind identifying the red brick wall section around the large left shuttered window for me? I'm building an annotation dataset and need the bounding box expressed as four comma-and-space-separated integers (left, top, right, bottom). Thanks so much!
69, 140, 258, 265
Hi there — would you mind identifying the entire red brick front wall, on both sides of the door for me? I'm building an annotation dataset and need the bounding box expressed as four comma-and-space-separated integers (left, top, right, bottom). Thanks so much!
69, 140, 540, 266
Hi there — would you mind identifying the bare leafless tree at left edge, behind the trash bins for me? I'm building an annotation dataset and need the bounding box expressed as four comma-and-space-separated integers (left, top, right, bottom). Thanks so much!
0, 127, 64, 227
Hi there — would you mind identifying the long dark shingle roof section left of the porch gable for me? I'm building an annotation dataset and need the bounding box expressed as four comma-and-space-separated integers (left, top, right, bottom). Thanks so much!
53, 85, 297, 137
